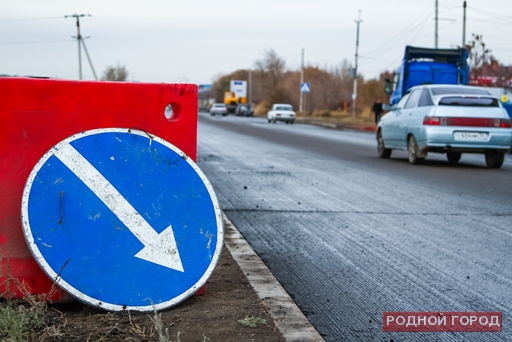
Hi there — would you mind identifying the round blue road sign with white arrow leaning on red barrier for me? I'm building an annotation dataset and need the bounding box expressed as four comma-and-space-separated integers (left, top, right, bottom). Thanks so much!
22, 128, 224, 311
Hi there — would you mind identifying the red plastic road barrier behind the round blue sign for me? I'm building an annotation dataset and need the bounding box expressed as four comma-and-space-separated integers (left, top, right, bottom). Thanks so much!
0, 78, 198, 300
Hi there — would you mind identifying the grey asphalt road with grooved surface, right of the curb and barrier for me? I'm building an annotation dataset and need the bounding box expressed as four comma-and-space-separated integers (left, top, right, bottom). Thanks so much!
194, 113, 512, 341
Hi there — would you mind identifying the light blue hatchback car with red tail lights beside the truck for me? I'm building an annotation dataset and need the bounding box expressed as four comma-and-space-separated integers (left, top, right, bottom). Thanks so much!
376, 85, 512, 168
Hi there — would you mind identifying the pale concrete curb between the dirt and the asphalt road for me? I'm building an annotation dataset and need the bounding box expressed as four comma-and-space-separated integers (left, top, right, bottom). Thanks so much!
224, 214, 324, 342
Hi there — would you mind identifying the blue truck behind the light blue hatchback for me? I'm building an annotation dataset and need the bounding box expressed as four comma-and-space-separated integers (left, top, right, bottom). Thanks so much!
386, 46, 469, 105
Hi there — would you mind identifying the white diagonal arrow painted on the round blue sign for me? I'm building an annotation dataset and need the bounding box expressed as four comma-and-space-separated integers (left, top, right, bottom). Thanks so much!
54, 144, 184, 272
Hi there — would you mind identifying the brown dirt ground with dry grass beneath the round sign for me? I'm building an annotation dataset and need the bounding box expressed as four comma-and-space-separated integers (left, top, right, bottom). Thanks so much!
22, 248, 284, 342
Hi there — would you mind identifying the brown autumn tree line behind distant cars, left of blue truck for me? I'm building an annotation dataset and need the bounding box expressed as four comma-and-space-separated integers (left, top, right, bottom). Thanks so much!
210, 49, 389, 115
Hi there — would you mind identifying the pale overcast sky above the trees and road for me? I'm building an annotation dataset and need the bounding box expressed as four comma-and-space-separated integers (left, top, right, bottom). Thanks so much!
0, 0, 512, 84
